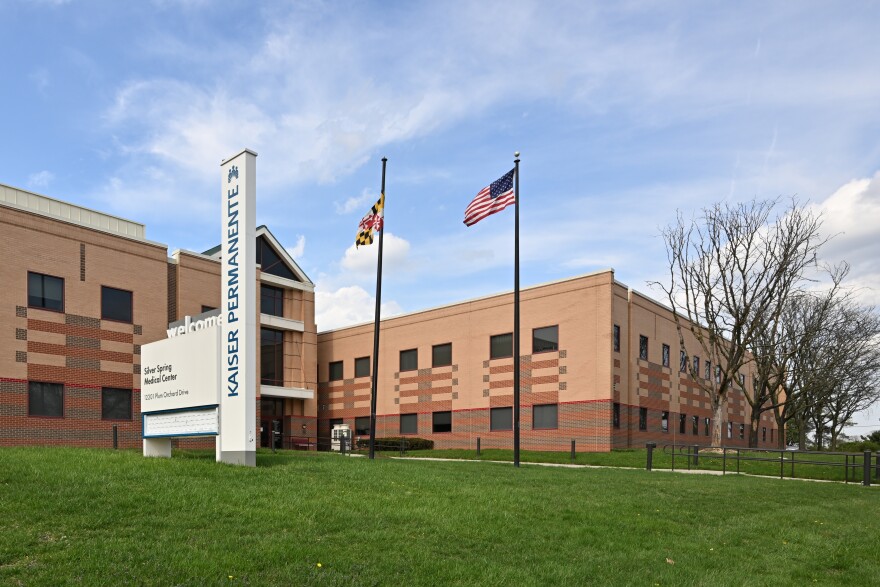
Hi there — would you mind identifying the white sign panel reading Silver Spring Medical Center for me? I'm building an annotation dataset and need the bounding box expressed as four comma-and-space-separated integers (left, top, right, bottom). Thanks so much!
141, 326, 220, 413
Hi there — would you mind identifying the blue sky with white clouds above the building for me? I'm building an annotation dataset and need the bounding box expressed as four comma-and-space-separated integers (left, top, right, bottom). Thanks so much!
0, 0, 880, 432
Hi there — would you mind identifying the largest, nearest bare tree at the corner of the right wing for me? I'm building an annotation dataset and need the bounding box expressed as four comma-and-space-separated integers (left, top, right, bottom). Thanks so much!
657, 200, 824, 446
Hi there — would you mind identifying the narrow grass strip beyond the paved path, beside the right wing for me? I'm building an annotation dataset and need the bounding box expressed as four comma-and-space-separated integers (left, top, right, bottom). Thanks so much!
406, 447, 876, 483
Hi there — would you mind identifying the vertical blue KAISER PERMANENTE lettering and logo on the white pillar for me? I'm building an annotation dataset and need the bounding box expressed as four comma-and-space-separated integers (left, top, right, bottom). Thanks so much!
223, 165, 240, 397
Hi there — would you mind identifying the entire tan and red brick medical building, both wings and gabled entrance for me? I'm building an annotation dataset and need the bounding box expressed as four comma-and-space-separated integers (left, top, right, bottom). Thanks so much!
0, 184, 778, 451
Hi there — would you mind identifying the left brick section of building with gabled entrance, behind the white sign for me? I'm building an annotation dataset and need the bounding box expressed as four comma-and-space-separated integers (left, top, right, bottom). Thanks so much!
0, 185, 317, 447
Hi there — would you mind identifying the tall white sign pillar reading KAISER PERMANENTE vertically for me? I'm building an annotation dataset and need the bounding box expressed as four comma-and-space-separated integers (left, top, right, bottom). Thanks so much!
217, 149, 259, 467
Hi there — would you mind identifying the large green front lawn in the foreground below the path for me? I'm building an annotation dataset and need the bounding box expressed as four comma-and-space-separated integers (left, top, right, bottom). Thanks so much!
0, 448, 880, 586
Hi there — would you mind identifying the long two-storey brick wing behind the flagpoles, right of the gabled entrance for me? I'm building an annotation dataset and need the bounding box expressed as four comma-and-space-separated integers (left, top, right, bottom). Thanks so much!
318, 270, 777, 451
